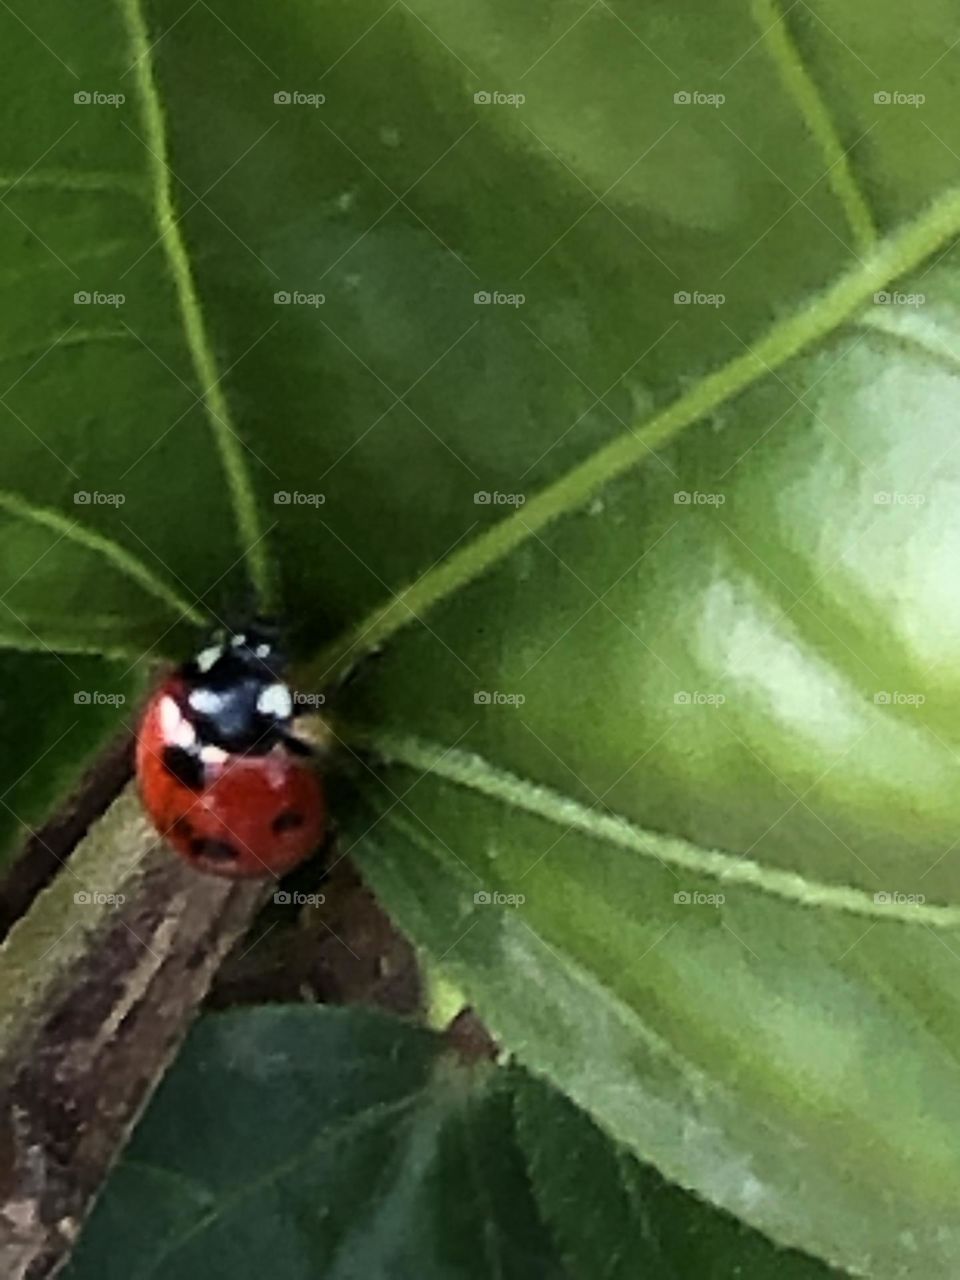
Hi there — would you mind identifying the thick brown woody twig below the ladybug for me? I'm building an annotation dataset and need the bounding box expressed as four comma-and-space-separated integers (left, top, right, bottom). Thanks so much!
0, 788, 273, 1280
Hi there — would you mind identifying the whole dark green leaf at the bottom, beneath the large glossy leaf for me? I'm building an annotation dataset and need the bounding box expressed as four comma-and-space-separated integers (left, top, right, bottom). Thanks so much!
67, 1006, 828, 1280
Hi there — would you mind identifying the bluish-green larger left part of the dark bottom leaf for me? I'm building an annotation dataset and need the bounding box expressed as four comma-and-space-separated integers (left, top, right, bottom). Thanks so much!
68, 1006, 563, 1280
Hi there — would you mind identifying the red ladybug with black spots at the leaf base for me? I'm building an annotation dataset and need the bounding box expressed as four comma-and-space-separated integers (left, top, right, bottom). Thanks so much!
137, 626, 326, 877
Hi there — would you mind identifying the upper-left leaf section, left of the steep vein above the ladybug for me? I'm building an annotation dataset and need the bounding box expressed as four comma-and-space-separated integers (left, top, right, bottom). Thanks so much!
0, 0, 268, 658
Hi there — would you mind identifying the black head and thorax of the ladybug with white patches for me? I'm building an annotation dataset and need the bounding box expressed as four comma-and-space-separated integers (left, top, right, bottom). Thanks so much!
182, 623, 293, 755
